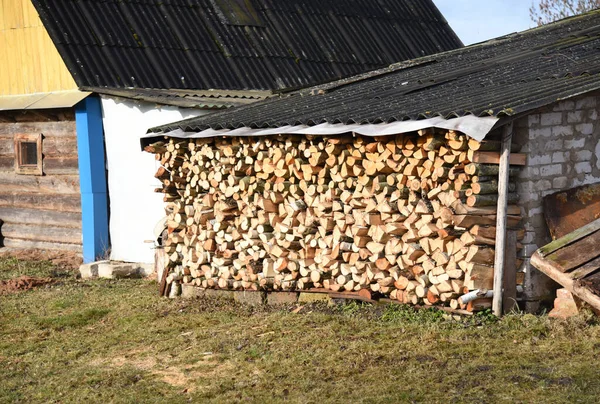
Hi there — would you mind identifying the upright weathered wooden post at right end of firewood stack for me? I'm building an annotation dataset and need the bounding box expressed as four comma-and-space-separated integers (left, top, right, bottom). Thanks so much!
492, 122, 513, 316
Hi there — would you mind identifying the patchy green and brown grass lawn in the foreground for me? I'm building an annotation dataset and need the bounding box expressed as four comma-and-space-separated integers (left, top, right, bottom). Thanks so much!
0, 258, 600, 403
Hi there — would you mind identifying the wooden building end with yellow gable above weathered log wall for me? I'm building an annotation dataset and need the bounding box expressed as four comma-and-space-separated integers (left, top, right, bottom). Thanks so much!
0, 0, 89, 252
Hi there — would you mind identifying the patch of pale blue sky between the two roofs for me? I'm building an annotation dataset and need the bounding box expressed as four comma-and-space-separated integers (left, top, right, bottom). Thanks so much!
433, 0, 535, 45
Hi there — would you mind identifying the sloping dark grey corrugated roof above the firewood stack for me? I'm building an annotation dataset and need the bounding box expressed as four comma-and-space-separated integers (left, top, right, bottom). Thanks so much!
151, 11, 600, 132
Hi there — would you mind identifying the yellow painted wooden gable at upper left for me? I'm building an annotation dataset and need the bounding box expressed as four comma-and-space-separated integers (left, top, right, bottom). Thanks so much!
0, 0, 77, 96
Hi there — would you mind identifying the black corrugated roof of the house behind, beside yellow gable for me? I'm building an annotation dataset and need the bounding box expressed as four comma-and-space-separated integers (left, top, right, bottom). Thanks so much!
32, 0, 462, 90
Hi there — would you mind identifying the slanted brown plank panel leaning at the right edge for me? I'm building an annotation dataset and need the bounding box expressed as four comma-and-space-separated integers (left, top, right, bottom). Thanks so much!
531, 219, 600, 314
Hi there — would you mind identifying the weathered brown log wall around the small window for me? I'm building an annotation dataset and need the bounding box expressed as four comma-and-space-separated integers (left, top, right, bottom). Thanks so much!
0, 109, 82, 251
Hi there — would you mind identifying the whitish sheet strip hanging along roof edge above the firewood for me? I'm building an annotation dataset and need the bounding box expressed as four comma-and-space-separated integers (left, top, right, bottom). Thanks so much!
140, 115, 500, 149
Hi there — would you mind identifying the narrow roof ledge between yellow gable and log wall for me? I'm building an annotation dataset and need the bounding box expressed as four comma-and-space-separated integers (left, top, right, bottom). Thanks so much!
0, 90, 92, 111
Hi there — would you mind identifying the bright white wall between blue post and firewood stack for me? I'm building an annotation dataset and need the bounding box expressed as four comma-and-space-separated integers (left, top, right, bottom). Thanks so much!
102, 97, 209, 263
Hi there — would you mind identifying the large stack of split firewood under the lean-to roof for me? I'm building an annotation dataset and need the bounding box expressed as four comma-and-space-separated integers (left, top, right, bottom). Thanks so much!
145, 130, 520, 309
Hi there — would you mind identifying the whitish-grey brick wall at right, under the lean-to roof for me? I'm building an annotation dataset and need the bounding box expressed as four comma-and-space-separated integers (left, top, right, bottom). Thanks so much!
515, 92, 600, 310
